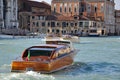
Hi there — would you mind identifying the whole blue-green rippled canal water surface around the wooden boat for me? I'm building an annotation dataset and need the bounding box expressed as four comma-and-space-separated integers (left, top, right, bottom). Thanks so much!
0, 37, 120, 80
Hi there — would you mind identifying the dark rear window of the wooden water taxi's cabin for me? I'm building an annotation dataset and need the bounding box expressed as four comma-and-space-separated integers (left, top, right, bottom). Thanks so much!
29, 48, 54, 56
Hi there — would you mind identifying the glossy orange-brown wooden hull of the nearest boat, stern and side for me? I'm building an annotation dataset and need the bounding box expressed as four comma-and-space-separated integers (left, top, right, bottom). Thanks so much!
11, 52, 75, 73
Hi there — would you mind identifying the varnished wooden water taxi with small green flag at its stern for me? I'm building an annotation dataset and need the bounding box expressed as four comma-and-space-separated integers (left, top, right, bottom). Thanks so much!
11, 41, 76, 73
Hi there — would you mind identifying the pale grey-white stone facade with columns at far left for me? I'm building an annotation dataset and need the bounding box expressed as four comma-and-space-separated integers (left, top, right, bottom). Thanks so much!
0, 0, 18, 29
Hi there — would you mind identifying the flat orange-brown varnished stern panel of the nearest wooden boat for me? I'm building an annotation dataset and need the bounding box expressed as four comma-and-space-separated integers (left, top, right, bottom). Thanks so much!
11, 61, 50, 72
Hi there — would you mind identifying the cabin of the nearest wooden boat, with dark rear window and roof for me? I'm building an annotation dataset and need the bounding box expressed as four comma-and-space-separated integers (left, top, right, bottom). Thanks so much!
22, 45, 71, 61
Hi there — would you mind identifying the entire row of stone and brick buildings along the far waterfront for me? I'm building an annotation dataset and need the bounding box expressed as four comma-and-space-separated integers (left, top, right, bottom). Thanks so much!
0, 0, 116, 36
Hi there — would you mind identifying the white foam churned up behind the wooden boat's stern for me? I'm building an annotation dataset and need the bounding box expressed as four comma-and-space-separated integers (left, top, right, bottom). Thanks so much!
0, 71, 55, 80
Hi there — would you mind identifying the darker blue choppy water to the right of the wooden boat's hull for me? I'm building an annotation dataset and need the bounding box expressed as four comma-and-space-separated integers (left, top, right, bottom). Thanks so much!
53, 62, 120, 76
